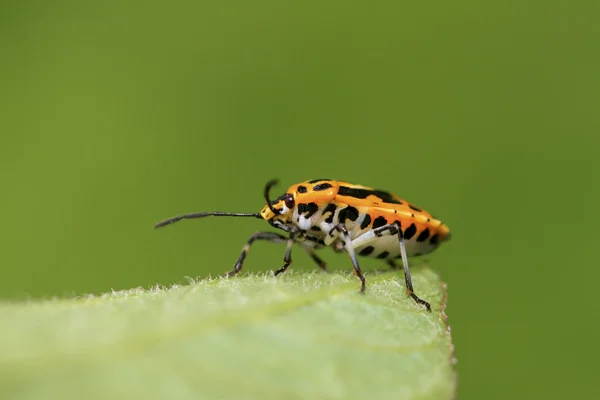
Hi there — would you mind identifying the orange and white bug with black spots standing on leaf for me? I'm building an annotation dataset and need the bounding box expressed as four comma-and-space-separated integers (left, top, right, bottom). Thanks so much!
155, 179, 450, 311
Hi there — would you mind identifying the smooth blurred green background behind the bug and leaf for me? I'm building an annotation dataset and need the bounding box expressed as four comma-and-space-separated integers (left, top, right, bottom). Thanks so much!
0, 0, 600, 399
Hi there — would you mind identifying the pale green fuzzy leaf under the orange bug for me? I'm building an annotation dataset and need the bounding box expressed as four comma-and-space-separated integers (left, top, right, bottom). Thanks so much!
0, 269, 455, 400
